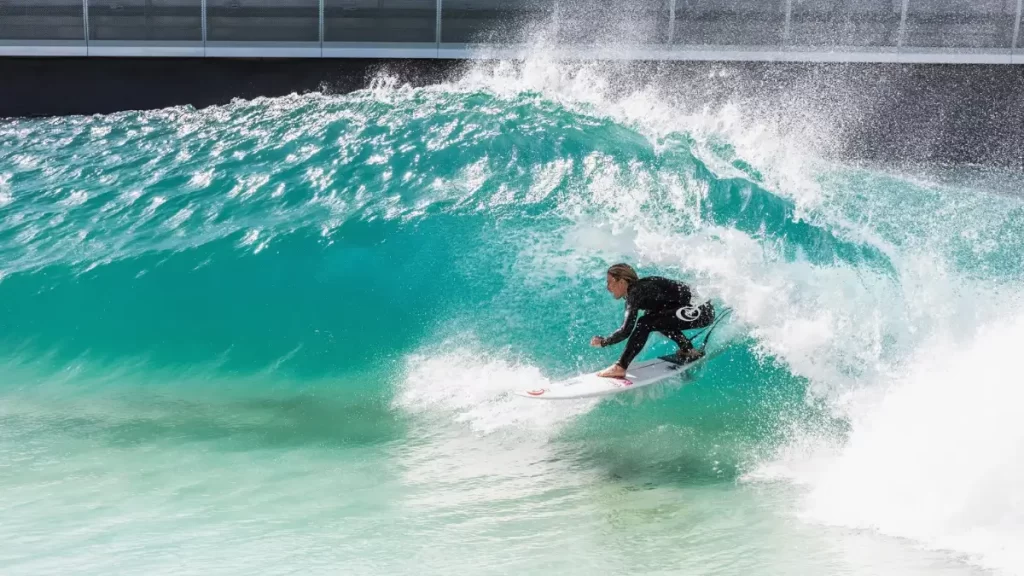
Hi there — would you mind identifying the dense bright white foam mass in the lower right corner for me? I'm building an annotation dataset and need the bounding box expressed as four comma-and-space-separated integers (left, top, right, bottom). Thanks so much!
761, 314, 1024, 574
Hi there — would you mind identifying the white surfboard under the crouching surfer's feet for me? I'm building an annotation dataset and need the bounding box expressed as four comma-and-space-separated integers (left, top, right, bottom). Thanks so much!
515, 353, 716, 400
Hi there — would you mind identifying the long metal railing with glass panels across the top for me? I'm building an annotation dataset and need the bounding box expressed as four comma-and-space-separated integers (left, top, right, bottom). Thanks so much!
0, 0, 1024, 64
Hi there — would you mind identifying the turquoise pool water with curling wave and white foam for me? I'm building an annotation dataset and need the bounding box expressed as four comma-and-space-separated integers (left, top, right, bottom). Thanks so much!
0, 61, 1024, 574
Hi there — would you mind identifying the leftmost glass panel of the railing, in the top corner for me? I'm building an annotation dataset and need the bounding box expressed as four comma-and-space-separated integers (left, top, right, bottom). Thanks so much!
0, 0, 85, 41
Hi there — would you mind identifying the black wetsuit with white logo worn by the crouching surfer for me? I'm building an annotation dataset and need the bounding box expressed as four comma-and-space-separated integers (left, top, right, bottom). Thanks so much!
601, 276, 715, 368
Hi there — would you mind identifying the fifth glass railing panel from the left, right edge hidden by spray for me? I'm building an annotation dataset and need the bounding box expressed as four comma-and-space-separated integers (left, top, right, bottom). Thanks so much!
441, 0, 555, 44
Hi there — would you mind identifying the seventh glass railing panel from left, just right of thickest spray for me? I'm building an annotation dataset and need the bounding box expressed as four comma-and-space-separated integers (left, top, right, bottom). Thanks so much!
673, 0, 785, 46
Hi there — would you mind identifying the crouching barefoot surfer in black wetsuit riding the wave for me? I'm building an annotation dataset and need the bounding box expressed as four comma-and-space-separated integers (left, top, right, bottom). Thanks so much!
590, 263, 715, 378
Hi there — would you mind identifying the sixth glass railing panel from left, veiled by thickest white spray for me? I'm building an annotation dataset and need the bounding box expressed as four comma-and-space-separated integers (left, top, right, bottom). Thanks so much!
557, 0, 671, 45
